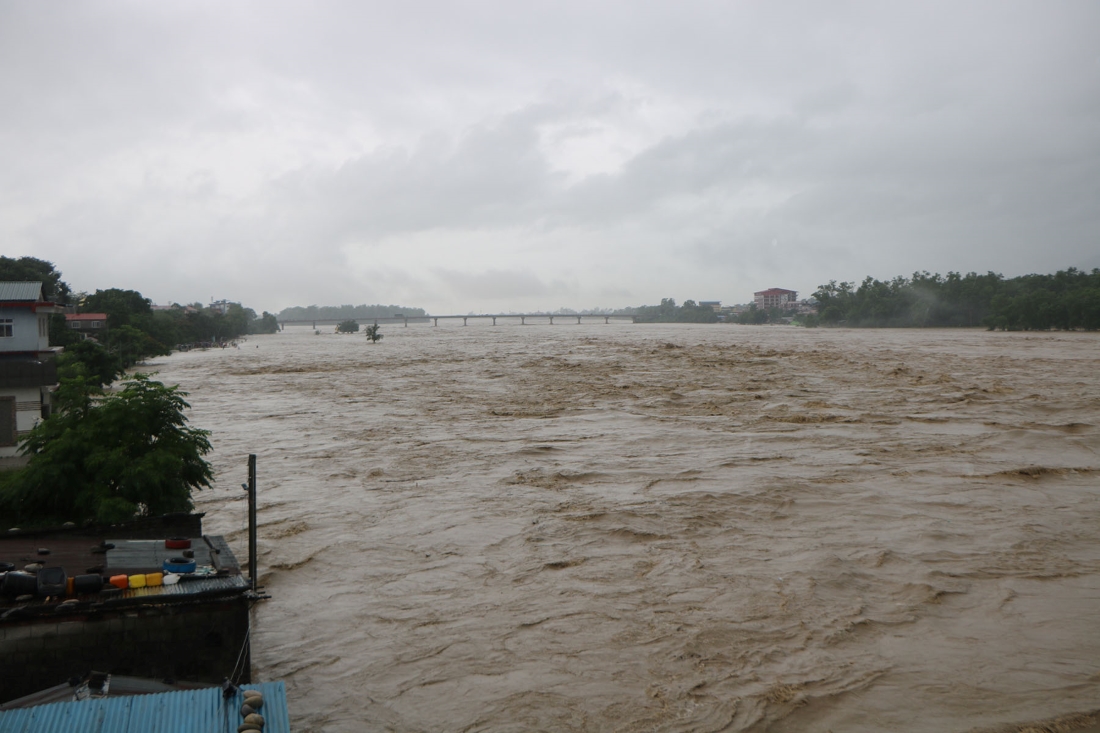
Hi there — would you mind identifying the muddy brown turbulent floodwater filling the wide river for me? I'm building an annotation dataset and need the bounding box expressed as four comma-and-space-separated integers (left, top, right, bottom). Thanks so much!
151, 324, 1100, 733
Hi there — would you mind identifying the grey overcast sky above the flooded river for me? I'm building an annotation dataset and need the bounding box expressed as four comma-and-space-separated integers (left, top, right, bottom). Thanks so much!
0, 0, 1100, 314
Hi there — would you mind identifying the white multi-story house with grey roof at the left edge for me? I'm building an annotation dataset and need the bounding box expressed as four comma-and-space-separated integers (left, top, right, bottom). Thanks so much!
0, 282, 63, 458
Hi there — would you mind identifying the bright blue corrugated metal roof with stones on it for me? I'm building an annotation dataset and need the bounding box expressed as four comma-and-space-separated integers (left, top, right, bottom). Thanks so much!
0, 682, 290, 733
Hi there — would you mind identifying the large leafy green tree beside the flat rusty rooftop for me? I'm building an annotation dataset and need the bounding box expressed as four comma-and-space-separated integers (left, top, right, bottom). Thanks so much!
0, 374, 213, 525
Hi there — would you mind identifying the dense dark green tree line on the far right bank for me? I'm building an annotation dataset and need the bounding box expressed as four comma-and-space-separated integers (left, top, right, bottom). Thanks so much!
806, 267, 1100, 330
